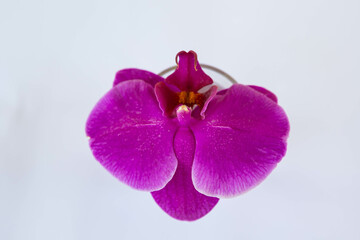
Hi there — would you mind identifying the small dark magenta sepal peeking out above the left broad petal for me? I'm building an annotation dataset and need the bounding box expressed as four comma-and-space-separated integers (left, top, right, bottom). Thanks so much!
113, 68, 164, 87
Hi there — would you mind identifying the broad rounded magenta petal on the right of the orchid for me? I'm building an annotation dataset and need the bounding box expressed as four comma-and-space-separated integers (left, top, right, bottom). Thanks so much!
191, 84, 289, 197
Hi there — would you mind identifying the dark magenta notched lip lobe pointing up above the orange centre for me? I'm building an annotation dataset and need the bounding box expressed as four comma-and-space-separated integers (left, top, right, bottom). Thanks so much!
165, 51, 213, 92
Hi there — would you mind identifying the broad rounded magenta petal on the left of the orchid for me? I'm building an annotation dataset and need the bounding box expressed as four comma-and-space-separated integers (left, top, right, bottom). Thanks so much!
86, 80, 177, 191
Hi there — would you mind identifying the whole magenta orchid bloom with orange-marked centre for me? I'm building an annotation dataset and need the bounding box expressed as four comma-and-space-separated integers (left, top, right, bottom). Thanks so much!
86, 51, 289, 221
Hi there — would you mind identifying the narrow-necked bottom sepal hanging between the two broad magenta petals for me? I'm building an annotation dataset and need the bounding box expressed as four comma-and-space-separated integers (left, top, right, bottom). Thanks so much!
151, 127, 219, 221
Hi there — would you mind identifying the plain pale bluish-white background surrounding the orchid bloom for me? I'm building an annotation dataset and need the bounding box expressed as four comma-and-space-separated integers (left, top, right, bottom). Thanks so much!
0, 0, 360, 240
